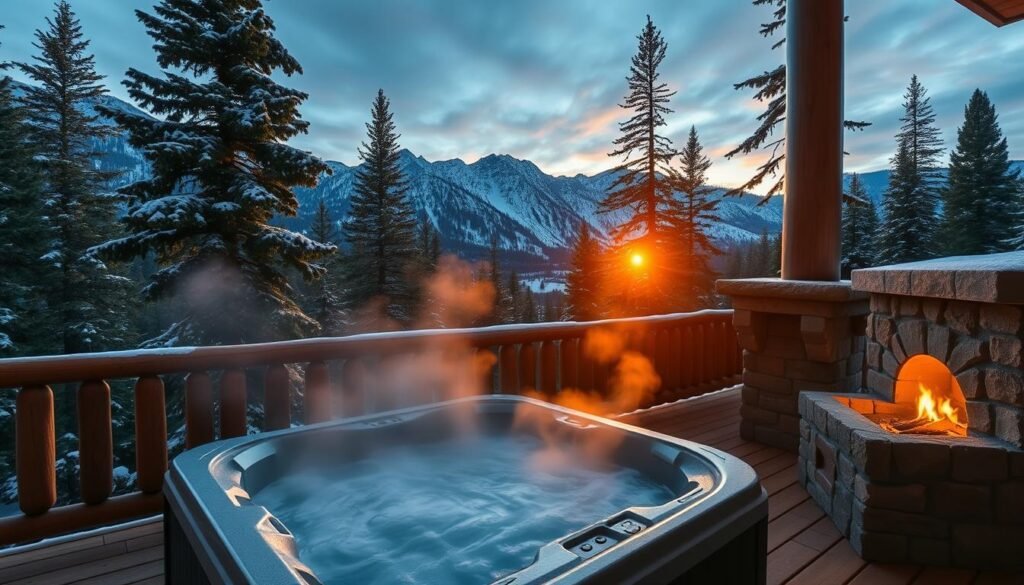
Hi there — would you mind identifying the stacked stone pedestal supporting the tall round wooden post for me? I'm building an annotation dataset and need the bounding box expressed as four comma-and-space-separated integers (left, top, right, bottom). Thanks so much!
718, 279, 868, 452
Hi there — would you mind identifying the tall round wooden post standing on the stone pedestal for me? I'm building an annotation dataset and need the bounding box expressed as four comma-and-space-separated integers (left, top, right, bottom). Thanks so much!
782, 0, 844, 281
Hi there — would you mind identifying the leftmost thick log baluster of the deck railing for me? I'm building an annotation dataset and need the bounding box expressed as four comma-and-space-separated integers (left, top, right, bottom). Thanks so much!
14, 386, 57, 516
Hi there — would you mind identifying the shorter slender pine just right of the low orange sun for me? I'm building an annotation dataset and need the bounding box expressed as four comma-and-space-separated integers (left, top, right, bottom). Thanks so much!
671, 126, 722, 310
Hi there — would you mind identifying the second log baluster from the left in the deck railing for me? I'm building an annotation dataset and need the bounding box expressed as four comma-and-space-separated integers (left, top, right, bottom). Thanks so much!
78, 380, 114, 504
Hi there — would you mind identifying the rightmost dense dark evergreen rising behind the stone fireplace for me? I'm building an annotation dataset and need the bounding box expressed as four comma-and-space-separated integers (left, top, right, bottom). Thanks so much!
940, 89, 1020, 255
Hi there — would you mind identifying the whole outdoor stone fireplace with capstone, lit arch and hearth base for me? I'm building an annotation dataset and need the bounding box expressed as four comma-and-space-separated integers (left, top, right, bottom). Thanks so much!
799, 252, 1024, 569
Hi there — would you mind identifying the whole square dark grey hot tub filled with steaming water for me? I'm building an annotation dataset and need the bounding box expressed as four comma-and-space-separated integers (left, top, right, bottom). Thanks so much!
165, 395, 768, 585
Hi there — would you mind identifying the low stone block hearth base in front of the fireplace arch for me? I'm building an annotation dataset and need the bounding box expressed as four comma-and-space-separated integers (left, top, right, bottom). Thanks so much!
798, 392, 1024, 570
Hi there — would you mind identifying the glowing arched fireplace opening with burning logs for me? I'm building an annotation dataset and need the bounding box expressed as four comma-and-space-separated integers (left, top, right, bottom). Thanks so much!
880, 354, 968, 436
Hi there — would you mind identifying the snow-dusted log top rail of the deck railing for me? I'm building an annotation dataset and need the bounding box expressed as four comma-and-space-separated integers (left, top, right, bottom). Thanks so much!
0, 309, 732, 388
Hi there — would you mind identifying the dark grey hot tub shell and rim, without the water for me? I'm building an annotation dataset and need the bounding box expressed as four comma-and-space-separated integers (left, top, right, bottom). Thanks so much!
164, 395, 768, 585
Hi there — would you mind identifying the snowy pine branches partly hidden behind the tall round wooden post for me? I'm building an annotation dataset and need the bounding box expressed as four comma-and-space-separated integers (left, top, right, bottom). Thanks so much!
725, 0, 871, 197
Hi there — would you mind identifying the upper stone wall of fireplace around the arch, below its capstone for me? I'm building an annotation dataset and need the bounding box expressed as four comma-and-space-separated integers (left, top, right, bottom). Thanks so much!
865, 293, 1024, 447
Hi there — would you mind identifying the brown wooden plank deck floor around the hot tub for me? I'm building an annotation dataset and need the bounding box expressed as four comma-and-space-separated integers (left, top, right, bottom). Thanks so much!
0, 389, 1024, 585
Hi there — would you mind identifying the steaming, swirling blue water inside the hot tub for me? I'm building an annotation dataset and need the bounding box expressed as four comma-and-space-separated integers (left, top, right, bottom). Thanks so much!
255, 435, 673, 584
